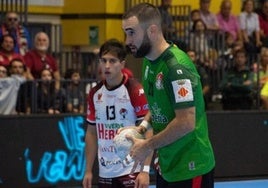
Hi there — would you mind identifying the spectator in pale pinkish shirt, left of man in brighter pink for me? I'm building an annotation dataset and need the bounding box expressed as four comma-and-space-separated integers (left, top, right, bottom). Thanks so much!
199, 0, 219, 30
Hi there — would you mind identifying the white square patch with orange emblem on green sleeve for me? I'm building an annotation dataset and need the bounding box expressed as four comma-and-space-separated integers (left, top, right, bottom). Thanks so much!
172, 79, 194, 103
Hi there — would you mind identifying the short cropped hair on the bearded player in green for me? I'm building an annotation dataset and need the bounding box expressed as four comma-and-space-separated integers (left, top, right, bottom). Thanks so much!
122, 3, 162, 27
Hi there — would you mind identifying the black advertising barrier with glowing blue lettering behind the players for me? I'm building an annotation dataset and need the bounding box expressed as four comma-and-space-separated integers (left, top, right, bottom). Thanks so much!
0, 111, 268, 188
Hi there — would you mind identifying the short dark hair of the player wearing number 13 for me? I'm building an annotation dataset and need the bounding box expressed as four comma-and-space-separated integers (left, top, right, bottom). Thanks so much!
99, 39, 127, 61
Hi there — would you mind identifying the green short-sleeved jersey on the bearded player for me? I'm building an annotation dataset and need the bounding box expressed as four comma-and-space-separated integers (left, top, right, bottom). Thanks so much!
142, 45, 215, 182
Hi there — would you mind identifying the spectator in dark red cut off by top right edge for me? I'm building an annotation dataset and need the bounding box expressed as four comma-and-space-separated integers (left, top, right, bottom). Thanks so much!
259, 0, 268, 47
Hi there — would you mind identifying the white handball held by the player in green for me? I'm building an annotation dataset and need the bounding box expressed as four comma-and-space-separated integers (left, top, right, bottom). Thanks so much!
113, 128, 144, 160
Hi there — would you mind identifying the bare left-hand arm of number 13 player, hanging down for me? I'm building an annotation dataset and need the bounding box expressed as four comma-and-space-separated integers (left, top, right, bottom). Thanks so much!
83, 124, 97, 188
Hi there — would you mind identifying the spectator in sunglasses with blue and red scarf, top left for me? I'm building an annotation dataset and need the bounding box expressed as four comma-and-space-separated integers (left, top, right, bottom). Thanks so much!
0, 12, 31, 55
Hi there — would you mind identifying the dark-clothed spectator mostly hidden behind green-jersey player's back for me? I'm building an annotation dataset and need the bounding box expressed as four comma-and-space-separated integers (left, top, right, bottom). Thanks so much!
187, 49, 211, 110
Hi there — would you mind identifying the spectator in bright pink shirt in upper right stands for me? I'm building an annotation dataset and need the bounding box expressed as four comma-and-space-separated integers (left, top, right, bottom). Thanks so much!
217, 0, 242, 40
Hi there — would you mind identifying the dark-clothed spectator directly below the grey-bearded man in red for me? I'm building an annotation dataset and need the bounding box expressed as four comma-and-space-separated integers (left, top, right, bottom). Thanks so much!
37, 68, 66, 114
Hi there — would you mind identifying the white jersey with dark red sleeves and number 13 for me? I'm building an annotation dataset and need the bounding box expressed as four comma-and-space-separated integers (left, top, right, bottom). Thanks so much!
87, 75, 148, 178
